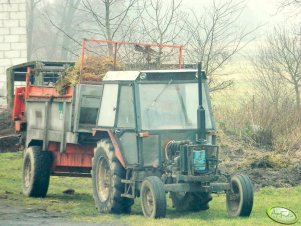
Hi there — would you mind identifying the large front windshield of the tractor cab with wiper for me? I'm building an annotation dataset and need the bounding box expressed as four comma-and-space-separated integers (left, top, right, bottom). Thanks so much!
139, 80, 198, 130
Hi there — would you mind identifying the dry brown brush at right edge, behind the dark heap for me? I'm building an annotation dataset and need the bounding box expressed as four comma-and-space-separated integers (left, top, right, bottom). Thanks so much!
215, 92, 301, 153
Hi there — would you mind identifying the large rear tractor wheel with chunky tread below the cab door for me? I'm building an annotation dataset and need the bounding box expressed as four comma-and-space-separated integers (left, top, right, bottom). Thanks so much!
91, 139, 134, 214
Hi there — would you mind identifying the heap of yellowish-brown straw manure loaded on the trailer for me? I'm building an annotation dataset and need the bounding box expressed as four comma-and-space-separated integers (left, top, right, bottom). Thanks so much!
55, 56, 124, 93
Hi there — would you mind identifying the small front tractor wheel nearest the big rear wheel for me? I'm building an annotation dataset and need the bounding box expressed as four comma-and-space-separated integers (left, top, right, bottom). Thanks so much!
140, 176, 166, 218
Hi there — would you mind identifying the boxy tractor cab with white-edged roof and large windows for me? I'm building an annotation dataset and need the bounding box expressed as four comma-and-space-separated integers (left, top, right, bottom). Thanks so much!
96, 70, 215, 168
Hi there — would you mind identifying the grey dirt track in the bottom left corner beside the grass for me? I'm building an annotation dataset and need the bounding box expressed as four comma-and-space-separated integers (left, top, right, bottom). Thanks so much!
0, 200, 124, 226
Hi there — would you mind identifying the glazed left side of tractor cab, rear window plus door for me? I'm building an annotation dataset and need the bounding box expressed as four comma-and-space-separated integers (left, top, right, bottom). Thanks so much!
98, 83, 138, 166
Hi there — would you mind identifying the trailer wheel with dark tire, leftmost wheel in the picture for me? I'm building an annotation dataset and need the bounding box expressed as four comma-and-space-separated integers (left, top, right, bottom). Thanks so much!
22, 146, 53, 198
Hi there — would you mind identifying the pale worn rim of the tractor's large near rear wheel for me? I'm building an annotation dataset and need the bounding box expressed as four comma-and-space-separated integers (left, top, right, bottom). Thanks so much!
97, 157, 111, 202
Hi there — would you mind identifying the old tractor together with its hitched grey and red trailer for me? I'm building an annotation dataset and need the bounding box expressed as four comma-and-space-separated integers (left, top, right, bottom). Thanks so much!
8, 62, 253, 218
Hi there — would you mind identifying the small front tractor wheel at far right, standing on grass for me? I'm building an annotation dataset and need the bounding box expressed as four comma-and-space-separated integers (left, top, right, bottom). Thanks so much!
226, 174, 254, 217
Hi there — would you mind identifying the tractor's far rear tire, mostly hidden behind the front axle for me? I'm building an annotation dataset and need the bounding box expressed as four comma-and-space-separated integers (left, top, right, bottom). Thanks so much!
170, 192, 212, 212
